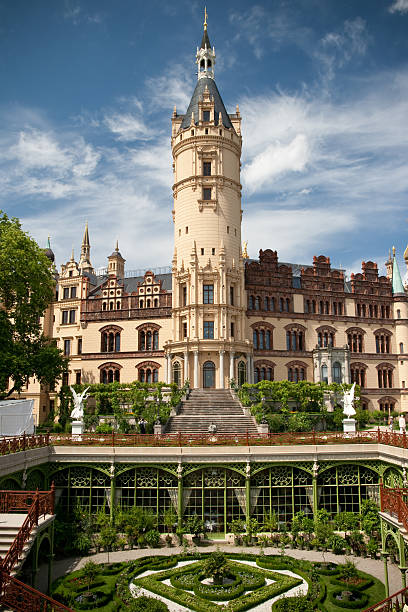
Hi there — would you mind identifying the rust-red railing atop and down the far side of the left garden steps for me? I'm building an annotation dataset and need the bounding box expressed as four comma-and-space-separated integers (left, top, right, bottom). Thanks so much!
0, 485, 55, 573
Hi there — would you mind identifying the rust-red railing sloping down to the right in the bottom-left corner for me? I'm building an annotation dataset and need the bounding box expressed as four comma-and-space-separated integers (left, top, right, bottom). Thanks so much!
0, 569, 72, 612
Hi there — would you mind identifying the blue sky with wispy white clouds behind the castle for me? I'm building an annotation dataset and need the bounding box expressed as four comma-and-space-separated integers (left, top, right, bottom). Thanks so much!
0, 0, 408, 273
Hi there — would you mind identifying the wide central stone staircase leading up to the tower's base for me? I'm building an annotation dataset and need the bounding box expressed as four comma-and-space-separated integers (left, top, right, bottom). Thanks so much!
166, 389, 258, 436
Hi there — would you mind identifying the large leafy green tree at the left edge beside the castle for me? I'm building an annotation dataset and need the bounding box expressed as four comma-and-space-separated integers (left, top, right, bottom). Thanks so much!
0, 211, 68, 397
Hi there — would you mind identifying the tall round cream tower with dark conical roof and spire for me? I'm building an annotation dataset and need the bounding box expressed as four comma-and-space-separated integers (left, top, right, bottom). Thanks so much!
166, 15, 252, 388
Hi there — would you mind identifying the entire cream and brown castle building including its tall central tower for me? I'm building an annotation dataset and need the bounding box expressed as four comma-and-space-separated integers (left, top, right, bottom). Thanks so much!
22, 16, 408, 423
